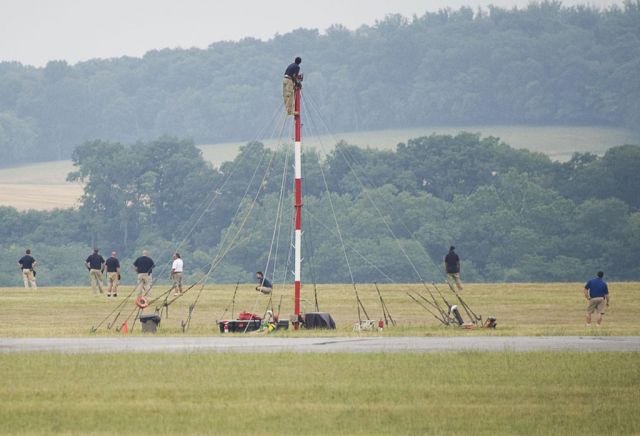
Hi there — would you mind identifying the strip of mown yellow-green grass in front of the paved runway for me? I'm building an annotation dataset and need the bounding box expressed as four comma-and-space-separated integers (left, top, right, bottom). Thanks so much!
0, 352, 640, 435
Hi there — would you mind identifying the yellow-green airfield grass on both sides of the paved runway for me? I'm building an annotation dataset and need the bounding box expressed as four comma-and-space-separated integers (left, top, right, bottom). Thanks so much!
0, 282, 640, 435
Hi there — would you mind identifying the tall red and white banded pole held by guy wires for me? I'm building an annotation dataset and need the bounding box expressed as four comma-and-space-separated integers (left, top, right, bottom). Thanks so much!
294, 82, 302, 317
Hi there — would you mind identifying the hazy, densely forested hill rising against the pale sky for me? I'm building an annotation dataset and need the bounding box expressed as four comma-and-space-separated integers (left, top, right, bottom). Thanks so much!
0, 0, 640, 165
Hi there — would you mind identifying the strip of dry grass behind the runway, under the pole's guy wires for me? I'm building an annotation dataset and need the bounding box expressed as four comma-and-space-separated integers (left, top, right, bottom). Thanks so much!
0, 280, 640, 337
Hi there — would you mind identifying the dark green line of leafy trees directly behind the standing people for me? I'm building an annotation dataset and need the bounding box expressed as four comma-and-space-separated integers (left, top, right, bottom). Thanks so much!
0, 132, 640, 286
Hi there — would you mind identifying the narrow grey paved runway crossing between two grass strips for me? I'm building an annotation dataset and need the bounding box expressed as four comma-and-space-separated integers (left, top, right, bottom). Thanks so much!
0, 336, 640, 353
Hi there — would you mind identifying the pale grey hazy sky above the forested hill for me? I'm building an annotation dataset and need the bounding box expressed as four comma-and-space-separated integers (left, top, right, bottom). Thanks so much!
0, 0, 622, 66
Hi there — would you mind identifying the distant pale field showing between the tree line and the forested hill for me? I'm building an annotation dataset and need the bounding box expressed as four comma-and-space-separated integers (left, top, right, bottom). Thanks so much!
0, 126, 640, 210
